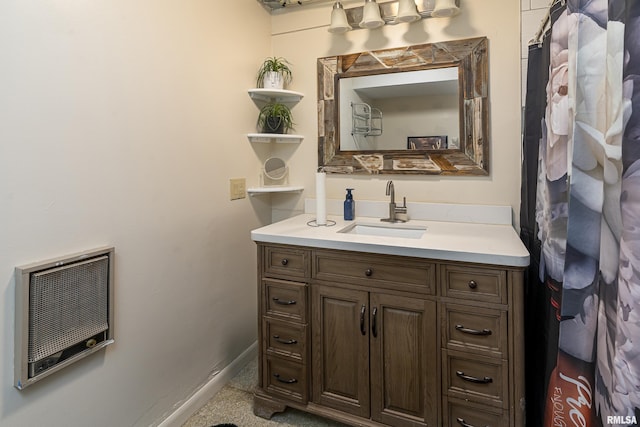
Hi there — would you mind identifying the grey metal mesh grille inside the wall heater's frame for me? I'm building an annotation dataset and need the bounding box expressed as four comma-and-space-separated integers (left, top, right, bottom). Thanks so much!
29, 256, 109, 362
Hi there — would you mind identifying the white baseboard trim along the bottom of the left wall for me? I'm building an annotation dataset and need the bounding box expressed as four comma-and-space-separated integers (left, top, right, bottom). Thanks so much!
158, 341, 258, 427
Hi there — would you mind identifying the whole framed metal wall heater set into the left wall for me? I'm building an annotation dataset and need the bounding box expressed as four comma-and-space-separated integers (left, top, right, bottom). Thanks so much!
14, 247, 114, 389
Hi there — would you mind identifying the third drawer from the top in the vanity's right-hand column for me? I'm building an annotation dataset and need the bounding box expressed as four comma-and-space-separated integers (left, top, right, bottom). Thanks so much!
442, 350, 508, 409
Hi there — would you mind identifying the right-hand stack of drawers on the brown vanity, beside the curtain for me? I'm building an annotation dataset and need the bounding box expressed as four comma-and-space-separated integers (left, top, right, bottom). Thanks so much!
440, 263, 524, 426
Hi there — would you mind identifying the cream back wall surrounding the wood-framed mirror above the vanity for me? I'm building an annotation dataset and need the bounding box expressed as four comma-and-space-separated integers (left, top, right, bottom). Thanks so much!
272, 0, 521, 227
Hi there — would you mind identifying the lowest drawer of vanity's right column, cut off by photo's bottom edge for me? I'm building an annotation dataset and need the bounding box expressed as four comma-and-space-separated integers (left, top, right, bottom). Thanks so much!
443, 397, 509, 427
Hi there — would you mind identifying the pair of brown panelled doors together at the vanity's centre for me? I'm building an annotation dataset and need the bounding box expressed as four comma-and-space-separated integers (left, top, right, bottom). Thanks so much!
311, 285, 438, 427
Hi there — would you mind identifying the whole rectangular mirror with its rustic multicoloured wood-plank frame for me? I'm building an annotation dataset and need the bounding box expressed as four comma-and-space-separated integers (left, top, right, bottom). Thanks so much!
317, 37, 490, 176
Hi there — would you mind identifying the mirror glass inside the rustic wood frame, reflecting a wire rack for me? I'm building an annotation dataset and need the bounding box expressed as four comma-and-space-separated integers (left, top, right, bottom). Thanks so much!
338, 67, 460, 151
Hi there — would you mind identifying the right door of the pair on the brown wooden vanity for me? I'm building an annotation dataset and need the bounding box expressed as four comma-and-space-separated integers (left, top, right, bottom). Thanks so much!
370, 293, 440, 427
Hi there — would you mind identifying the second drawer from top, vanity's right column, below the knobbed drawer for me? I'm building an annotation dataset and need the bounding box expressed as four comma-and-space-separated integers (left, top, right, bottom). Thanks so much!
441, 303, 508, 359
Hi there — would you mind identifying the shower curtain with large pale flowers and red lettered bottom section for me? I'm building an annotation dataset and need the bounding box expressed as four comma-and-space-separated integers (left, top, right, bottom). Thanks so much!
523, 0, 640, 427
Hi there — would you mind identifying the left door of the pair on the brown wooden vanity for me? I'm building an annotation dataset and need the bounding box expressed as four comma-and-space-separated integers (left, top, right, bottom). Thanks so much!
311, 285, 370, 418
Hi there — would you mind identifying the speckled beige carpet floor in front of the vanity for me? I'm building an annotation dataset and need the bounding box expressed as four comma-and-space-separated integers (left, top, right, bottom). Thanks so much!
182, 359, 346, 427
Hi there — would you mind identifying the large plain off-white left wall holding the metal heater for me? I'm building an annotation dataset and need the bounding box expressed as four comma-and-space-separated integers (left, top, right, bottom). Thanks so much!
0, 0, 271, 427
